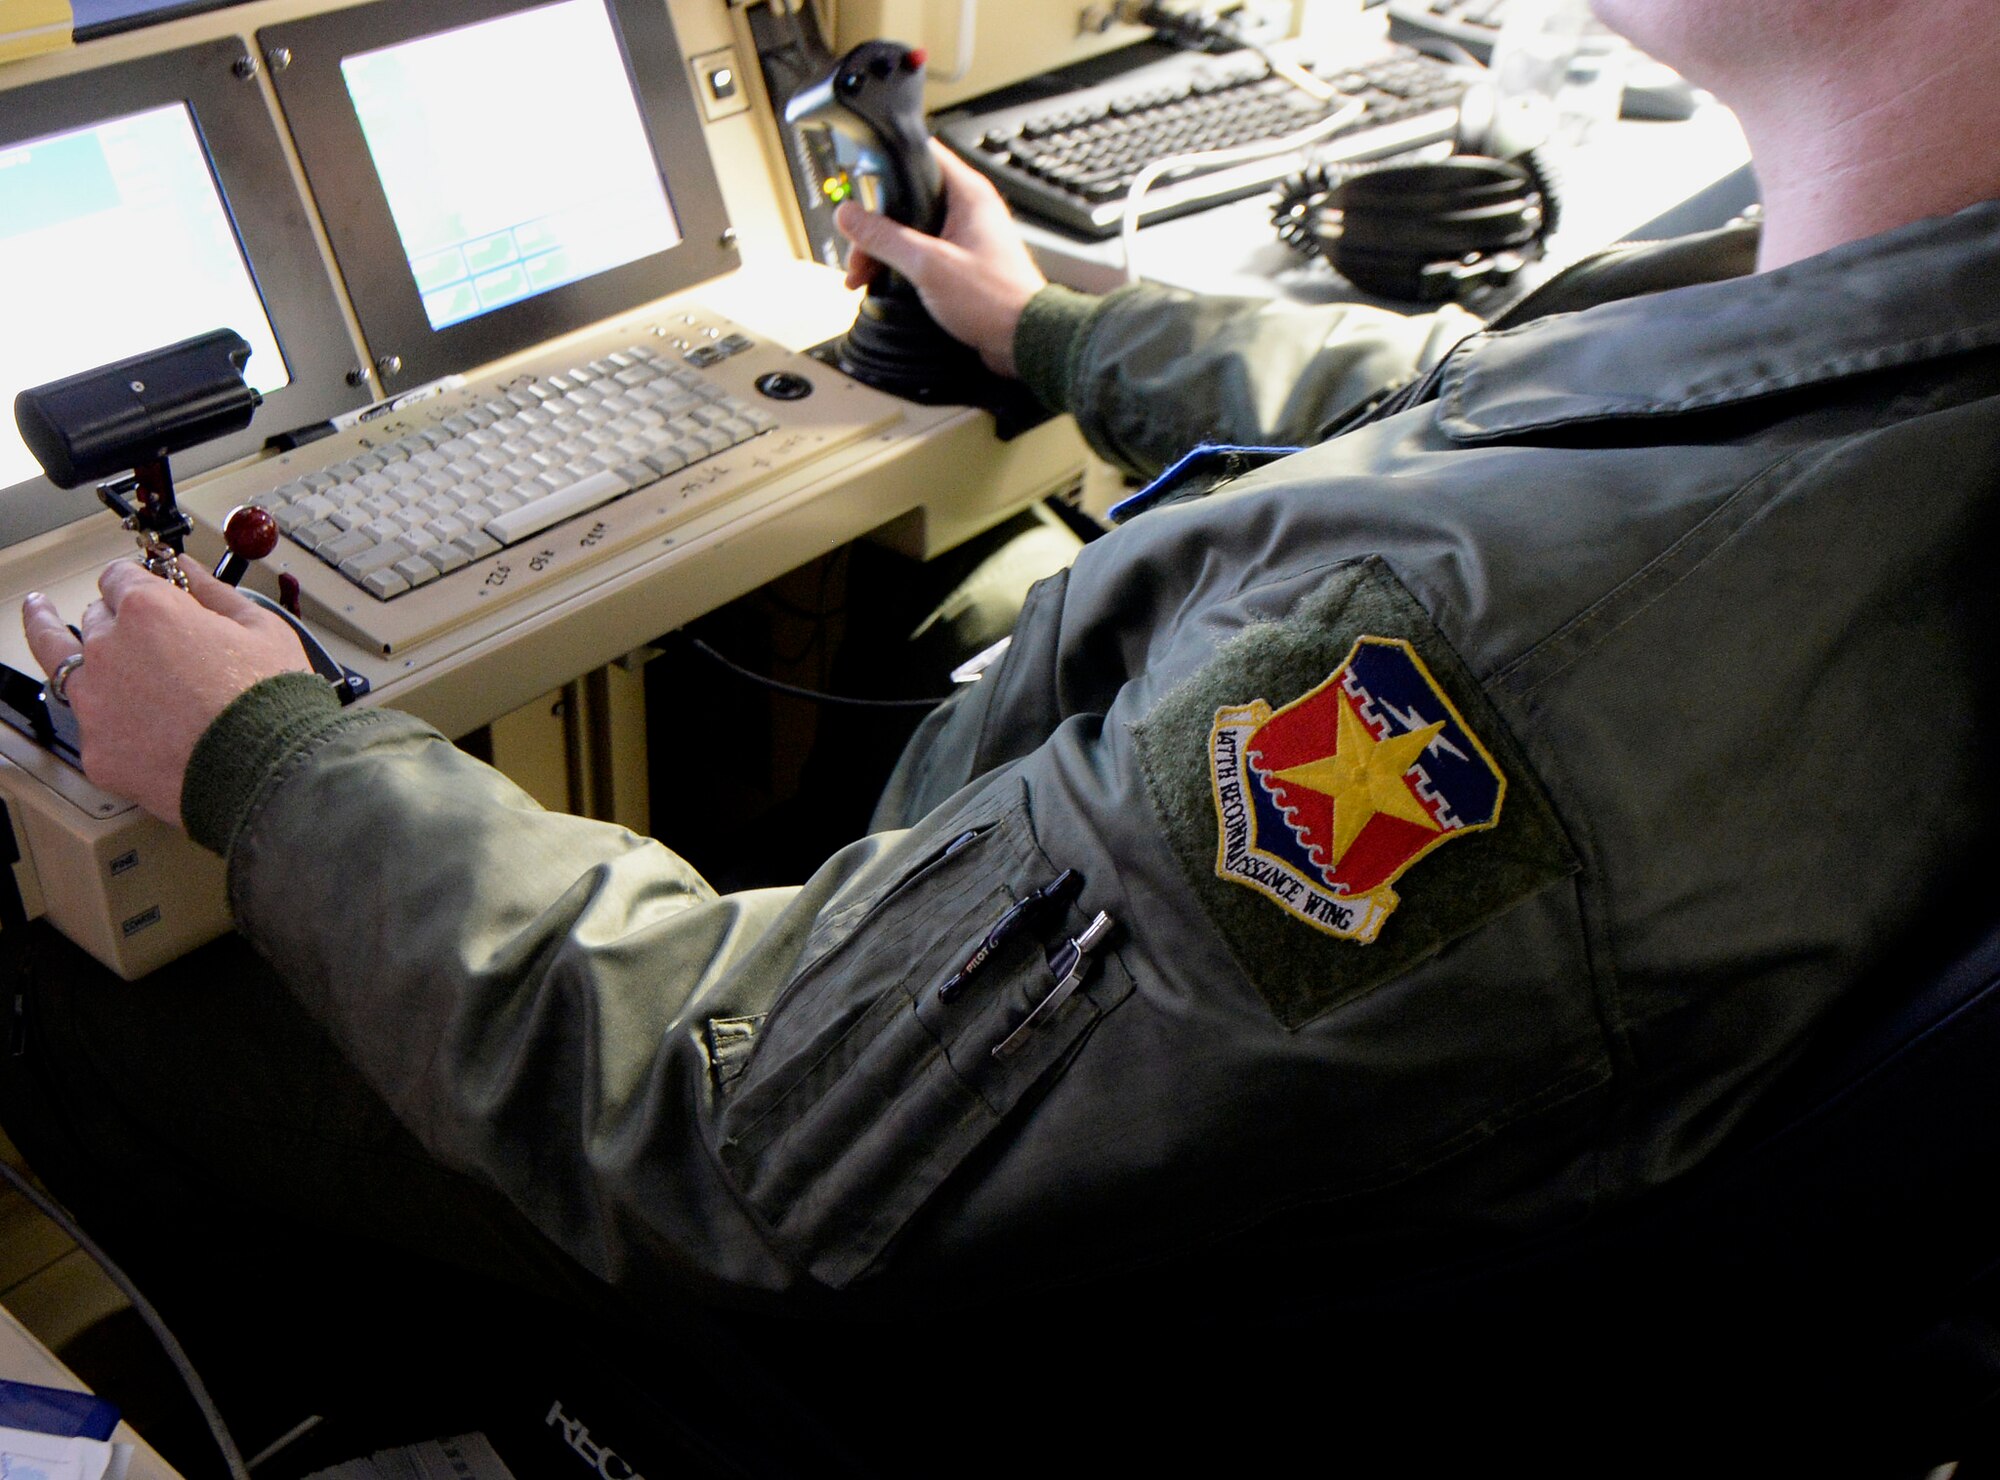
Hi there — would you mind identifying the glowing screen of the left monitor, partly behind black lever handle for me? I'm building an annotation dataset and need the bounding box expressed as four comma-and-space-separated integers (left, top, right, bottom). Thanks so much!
0, 102, 290, 486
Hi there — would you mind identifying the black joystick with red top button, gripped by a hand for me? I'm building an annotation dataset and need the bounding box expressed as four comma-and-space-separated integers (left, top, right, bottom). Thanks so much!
784, 42, 992, 404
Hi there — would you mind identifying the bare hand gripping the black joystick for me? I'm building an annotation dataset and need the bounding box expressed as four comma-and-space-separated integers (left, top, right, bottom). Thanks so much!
834, 140, 1048, 376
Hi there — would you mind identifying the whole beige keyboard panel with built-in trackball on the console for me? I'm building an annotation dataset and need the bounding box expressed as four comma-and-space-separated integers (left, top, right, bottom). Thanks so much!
182, 302, 904, 654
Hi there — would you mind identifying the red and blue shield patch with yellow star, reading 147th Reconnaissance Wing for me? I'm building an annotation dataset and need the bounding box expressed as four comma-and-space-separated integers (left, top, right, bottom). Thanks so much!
1208, 636, 1506, 944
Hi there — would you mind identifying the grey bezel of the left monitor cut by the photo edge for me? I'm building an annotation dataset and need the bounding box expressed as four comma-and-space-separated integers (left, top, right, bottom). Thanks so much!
0, 38, 368, 548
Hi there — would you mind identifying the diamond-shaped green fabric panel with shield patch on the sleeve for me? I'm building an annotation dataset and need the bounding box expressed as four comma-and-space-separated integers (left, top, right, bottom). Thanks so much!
1136, 560, 1576, 1026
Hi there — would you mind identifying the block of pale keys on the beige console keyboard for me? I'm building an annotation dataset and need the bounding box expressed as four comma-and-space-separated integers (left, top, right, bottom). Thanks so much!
264, 344, 778, 600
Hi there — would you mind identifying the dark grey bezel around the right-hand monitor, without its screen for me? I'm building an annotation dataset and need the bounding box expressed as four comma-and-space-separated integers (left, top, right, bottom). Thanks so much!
258, 0, 738, 394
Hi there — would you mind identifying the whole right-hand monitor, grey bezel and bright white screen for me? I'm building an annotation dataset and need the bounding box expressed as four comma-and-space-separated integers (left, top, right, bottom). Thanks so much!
258, 0, 736, 392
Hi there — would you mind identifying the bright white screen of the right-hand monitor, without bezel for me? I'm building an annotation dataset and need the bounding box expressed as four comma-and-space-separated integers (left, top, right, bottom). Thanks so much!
340, 0, 680, 328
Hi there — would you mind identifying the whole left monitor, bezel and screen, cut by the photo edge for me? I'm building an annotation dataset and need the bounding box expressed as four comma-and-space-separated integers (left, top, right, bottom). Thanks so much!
0, 40, 366, 546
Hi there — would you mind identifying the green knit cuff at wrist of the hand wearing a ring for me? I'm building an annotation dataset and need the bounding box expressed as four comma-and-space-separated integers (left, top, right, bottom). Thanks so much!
180, 674, 346, 858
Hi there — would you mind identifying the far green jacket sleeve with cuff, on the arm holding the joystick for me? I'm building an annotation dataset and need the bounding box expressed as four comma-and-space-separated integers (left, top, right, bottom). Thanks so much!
1014, 284, 1480, 476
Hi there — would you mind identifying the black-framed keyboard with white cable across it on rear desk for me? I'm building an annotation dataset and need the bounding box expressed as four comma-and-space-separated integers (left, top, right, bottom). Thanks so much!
932, 44, 1466, 238
